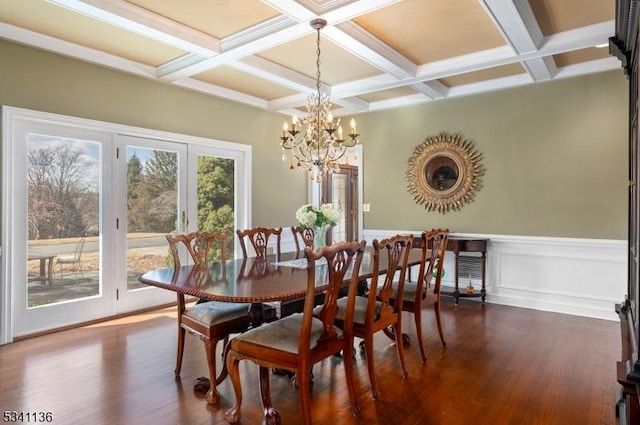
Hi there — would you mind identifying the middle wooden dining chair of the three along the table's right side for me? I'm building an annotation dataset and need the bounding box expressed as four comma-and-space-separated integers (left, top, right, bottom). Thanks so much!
336, 235, 413, 399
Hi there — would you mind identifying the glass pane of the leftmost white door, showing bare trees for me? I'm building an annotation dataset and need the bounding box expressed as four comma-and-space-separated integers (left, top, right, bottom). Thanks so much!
26, 134, 102, 308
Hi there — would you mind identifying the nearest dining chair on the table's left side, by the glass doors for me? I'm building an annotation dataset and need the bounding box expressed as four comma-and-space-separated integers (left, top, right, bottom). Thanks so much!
166, 232, 250, 404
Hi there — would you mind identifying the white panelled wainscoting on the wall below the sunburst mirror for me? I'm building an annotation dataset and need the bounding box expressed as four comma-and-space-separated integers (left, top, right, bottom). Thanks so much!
364, 229, 627, 320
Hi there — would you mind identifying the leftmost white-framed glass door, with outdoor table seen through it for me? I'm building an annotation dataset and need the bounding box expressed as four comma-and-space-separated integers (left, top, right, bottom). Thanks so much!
3, 120, 115, 336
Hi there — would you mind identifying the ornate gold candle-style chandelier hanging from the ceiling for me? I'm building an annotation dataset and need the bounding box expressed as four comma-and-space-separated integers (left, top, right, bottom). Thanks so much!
280, 19, 359, 182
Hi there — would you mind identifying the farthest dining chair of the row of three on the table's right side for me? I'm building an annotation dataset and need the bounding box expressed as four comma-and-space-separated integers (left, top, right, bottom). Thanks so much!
393, 229, 449, 363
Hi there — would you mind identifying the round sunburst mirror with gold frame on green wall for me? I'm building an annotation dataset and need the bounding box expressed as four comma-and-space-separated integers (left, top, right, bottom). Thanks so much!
406, 132, 485, 214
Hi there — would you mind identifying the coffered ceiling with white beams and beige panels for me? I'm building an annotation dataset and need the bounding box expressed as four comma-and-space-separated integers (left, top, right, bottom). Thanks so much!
0, 0, 621, 116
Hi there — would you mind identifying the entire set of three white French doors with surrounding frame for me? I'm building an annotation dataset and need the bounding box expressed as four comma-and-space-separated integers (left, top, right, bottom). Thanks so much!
0, 108, 250, 343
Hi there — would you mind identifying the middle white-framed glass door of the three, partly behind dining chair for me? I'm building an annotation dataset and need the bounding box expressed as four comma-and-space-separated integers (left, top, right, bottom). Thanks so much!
112, 135, 188, 313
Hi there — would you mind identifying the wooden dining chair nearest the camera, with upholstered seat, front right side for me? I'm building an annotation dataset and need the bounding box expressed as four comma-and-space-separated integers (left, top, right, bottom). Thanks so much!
225, 241, 366, 424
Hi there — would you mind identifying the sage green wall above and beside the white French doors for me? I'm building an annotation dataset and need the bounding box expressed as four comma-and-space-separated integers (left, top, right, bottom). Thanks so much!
0, 37, 307, 226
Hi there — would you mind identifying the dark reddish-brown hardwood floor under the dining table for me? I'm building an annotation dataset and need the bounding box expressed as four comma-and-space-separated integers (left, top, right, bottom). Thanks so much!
0, 298, 620, 425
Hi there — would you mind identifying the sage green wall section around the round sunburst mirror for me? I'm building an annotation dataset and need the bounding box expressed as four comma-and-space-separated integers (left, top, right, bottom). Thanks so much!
358, 69, 628, 239
